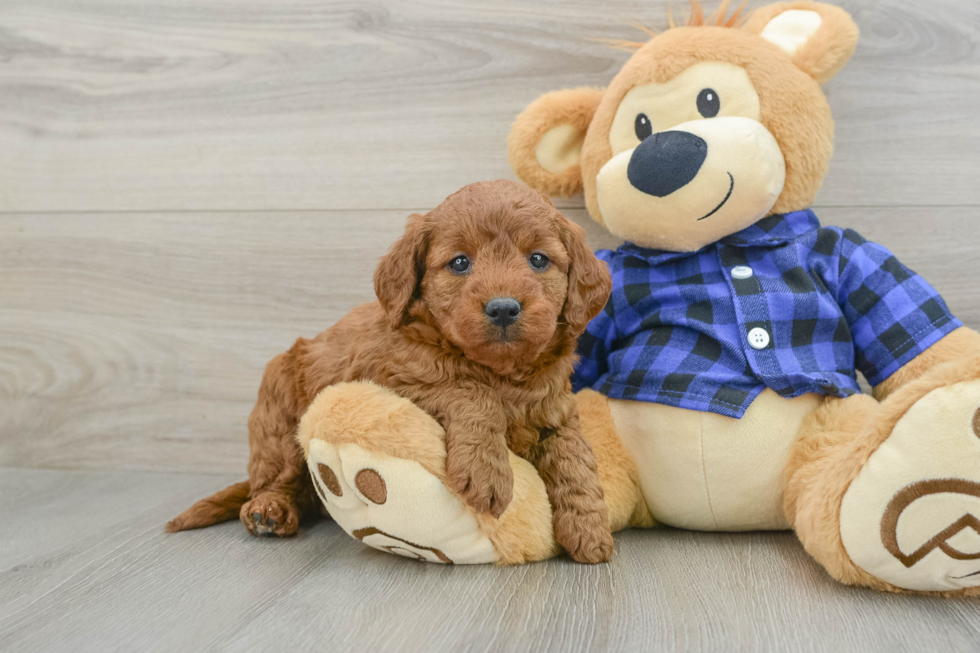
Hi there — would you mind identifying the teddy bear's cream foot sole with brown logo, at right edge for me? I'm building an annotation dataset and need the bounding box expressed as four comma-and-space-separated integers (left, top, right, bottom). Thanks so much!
840, 381, 980, 594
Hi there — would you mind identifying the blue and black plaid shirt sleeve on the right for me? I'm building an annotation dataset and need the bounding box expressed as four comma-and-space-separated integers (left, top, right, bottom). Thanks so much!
837, 229, 962, 386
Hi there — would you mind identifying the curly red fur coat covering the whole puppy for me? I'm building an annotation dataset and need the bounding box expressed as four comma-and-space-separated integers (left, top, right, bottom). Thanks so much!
171, 181, 612, 562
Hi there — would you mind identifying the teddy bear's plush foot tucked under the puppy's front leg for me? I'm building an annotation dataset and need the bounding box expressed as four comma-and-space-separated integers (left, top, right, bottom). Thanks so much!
297, 382, 558, 564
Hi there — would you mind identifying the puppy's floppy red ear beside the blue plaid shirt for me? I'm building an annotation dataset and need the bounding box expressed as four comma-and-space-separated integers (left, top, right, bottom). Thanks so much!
558, 214, 612, 335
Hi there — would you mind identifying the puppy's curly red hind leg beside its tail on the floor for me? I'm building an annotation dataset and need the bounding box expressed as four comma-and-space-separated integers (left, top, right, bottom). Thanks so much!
239, 351, 315, 537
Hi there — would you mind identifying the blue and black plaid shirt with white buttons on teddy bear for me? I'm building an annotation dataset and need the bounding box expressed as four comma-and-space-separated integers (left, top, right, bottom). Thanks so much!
572, 210, 961, 417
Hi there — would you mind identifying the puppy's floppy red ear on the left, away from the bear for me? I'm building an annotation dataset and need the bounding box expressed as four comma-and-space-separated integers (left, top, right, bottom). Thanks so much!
374, 213, 431, 329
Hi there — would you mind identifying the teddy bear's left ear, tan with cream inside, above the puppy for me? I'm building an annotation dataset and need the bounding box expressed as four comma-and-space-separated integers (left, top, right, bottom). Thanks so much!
507, 88, 603, 196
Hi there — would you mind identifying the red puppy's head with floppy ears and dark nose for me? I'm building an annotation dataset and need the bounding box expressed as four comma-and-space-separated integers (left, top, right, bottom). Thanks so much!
374, 181, 611, 371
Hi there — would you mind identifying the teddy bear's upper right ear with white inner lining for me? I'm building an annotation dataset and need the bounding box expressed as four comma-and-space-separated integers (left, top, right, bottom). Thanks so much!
743, 1, 859, 84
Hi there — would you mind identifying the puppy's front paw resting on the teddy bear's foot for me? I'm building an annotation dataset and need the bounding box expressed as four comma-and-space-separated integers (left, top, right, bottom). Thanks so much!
446, 451, 514, 518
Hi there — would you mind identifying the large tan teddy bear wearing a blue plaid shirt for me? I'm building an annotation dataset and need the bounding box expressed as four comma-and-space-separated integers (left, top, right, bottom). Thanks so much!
298, 1, 980, 595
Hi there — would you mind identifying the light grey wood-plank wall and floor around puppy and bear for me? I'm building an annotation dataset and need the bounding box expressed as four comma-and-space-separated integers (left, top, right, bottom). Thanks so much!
0, 0, 980, 652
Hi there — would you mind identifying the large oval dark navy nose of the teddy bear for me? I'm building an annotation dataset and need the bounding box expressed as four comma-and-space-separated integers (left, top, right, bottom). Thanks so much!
626, 132, 708, 197
